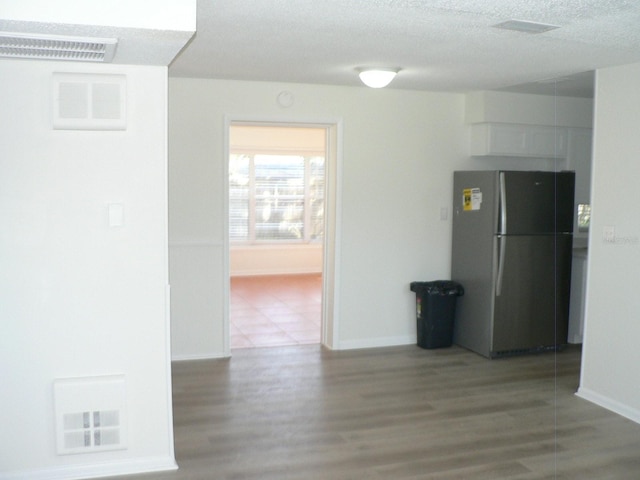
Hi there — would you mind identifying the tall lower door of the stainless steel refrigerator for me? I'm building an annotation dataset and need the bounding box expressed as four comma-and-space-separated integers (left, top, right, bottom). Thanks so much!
491, 235, 572, 356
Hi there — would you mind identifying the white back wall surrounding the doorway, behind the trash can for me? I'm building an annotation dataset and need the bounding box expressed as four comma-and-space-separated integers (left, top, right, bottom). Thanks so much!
169, 78, 476, 358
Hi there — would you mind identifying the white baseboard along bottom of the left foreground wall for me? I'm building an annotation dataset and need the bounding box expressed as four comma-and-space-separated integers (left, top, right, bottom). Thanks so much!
0, 457, 178, 480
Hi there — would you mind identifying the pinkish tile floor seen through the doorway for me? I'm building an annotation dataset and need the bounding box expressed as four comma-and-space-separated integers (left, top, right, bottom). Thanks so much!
230, 274, 322, 349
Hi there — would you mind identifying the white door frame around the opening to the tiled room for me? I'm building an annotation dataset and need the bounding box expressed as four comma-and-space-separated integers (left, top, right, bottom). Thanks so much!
222, 115, 342, 357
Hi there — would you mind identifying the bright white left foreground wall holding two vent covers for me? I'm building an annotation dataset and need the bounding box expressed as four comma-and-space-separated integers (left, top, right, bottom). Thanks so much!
0, 60, 175, 479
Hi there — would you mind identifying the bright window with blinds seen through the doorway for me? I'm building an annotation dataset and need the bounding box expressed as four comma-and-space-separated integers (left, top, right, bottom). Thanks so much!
229, 153, 325, 244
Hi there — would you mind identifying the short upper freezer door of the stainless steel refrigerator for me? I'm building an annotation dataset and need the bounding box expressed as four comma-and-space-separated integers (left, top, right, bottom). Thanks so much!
498, 171, 575, 235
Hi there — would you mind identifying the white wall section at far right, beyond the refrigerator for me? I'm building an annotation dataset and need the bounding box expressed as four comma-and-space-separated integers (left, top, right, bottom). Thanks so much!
579, 64, 640, 422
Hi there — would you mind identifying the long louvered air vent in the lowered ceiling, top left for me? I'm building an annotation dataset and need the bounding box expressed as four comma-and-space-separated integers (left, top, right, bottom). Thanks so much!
0, 32, 118, 62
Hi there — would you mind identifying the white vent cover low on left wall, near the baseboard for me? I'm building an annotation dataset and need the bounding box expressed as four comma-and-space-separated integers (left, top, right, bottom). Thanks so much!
53, 375, 127, 455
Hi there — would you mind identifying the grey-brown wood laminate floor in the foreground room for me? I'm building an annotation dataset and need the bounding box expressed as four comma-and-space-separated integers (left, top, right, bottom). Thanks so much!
110, 345, 640, 480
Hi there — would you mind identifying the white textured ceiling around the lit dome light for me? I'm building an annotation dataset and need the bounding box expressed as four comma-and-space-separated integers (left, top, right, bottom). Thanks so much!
169, 0, 640, 96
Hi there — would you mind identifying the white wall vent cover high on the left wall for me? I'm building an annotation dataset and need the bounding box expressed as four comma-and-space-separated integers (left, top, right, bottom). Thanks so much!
53, 73, 127, 130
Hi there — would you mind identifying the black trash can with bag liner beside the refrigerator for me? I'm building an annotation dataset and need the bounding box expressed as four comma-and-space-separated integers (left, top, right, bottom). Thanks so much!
411, 280, 464, 349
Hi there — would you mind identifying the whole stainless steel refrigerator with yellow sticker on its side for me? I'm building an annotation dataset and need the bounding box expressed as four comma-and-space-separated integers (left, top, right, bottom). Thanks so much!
451, 171, 575, 358
